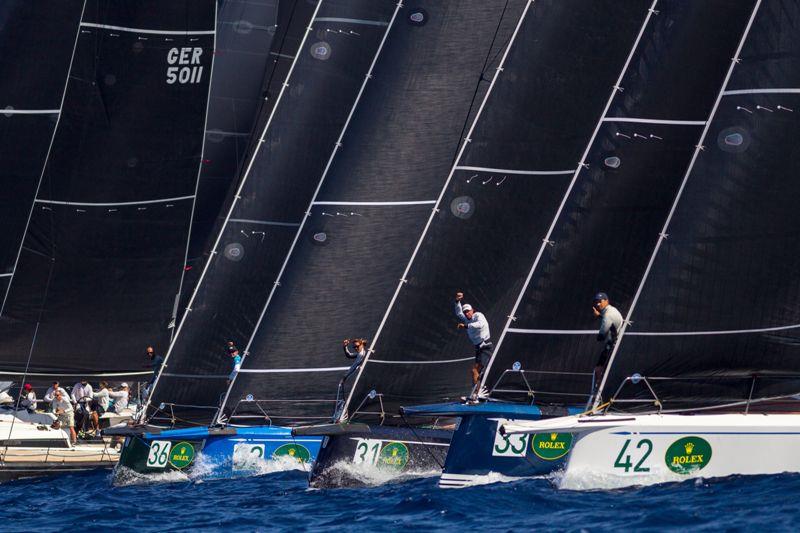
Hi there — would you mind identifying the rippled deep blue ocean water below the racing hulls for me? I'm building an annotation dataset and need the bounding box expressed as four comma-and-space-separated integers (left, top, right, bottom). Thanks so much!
0, 472, 800, 532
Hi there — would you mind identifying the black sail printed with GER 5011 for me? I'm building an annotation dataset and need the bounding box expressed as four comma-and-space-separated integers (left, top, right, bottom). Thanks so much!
0, 0, 215, 376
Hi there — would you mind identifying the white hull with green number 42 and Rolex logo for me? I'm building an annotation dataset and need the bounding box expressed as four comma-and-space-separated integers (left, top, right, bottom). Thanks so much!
507, 414, 800, 490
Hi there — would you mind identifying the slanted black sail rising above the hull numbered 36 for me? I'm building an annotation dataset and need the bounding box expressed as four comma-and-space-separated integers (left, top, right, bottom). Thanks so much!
148, 0, 395, 424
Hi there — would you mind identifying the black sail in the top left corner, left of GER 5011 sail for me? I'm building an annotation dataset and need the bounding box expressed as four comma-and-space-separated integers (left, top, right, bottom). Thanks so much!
0, 0, 83, 313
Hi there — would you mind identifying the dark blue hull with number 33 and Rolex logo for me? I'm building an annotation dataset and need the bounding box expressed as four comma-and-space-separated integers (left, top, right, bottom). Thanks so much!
404, 402, 583, 488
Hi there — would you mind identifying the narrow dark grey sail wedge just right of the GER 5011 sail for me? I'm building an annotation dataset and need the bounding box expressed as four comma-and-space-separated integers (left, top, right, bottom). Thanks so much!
174, 0, 296, 322
